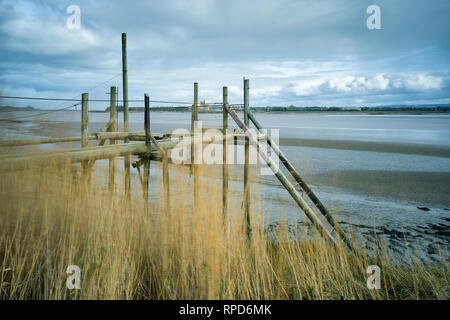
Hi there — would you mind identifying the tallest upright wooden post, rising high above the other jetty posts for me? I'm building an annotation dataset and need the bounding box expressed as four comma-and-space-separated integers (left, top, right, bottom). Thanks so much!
122, 33, 131, 200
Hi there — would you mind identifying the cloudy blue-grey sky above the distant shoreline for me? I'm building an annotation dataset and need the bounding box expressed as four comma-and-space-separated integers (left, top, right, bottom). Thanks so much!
0, 0, 450, 109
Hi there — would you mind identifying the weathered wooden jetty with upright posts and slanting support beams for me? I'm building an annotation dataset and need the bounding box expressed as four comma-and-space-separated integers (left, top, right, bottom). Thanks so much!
0, 34, 357, 253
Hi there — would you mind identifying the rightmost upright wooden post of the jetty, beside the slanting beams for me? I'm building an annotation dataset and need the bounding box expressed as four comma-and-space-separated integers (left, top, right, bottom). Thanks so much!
244, 78, 252, 239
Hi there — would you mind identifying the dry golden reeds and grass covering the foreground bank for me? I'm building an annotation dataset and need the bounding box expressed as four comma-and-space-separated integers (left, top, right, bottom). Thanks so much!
0, 159, 449, 299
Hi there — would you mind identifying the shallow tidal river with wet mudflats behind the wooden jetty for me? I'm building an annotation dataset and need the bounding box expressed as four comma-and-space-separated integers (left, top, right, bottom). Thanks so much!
0, 112, 450, 257
